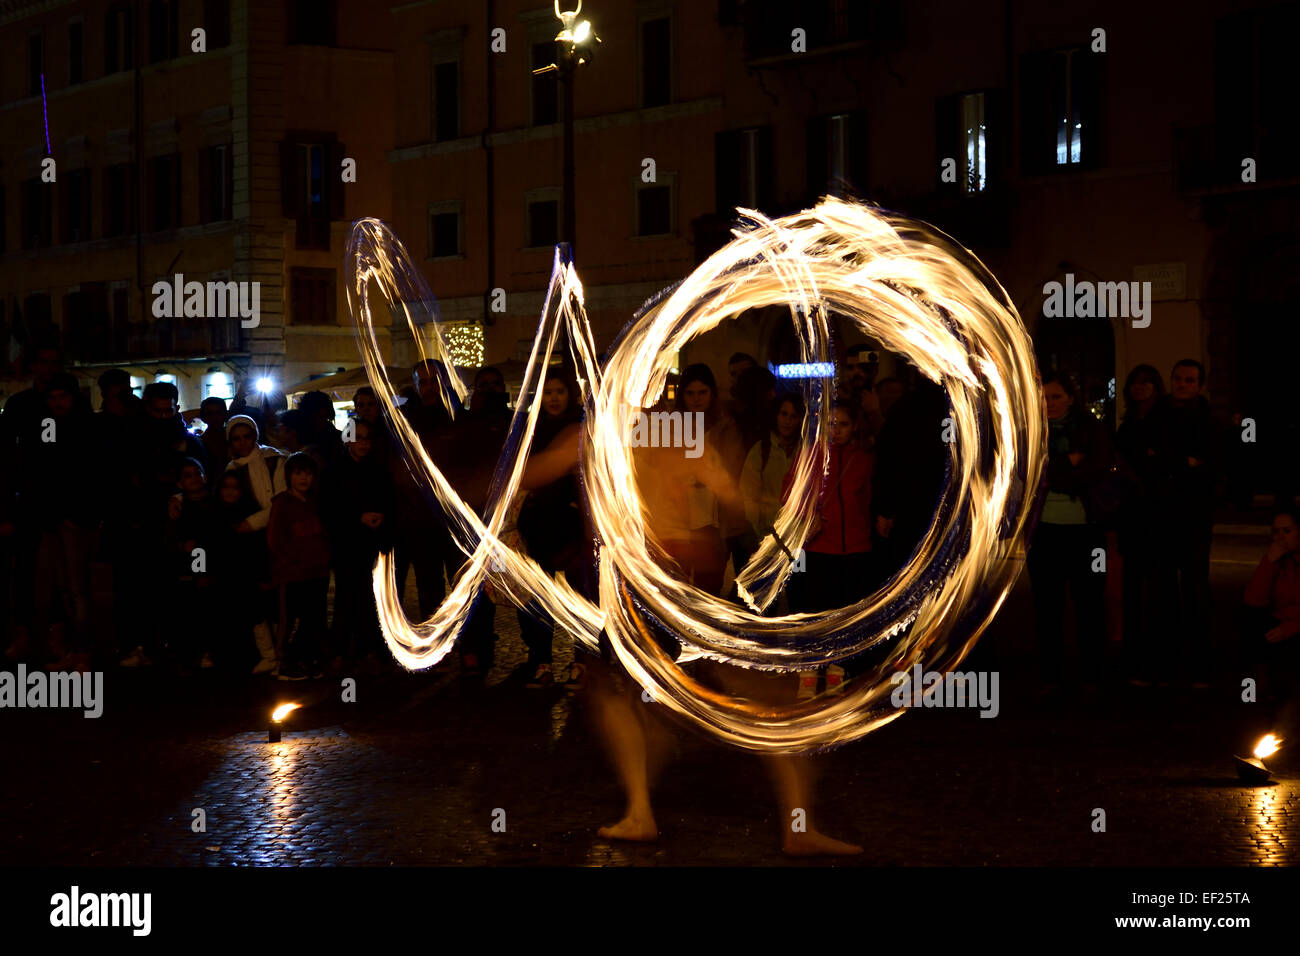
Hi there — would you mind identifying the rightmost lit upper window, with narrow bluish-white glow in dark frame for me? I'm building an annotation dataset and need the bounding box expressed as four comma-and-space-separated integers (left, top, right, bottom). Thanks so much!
1021, 47, 1101, 173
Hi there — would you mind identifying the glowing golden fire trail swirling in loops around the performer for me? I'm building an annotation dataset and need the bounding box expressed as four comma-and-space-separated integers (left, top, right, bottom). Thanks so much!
347, 199, 1047, 753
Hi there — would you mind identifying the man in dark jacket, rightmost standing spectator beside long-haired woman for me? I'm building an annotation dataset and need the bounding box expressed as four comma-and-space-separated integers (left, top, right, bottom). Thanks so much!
1151, 359, 1218, 688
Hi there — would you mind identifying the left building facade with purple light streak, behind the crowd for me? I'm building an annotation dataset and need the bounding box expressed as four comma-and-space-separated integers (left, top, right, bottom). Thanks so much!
0, 0, 393, 407
